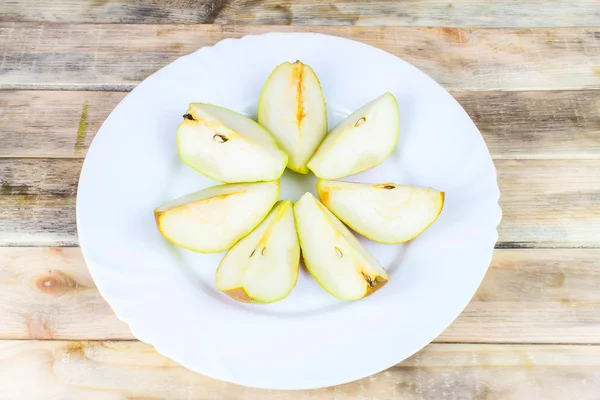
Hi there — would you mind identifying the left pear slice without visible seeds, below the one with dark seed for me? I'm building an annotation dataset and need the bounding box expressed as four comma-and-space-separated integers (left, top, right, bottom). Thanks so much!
154, 181, 279, 253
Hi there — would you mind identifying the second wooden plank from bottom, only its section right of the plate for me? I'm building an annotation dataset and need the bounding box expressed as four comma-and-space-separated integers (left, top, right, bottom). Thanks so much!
437, 249, 600, 343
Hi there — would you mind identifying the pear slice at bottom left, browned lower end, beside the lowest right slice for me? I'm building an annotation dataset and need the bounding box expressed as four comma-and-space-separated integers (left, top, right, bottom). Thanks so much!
217, 200, 300, 303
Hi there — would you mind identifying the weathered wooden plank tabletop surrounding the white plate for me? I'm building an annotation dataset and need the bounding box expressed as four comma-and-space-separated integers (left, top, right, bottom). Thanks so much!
0, 0, 600, 400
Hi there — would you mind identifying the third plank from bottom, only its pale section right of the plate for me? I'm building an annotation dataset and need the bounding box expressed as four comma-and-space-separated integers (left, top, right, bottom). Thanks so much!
495, 160, 600, 247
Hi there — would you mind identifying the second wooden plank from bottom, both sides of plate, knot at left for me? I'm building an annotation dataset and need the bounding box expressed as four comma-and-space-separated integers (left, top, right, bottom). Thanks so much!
0, 247, 600, 344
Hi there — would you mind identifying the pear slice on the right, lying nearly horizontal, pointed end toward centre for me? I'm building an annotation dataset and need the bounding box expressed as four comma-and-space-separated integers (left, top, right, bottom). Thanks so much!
317, 180, 444, 243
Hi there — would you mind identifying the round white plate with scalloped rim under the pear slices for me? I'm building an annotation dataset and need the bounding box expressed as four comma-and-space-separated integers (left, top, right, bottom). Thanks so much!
77, 33, 501, 389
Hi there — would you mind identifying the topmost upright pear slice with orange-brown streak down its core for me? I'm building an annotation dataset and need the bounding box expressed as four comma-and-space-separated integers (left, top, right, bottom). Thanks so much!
258, 61, 327, 174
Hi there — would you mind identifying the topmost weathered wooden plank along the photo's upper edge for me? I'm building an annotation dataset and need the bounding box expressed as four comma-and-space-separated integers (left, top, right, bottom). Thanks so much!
0, 0, 600, 27
